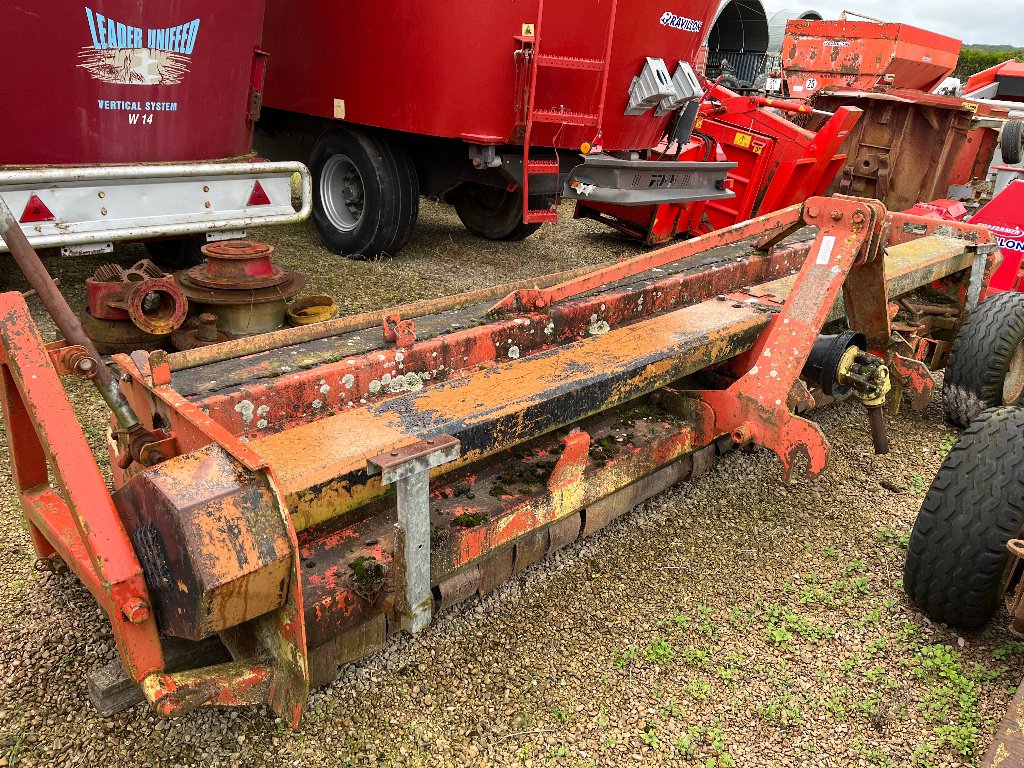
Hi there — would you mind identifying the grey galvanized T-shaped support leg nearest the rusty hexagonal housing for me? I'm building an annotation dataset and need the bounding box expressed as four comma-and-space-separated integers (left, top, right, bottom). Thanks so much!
367, 435, 462, 634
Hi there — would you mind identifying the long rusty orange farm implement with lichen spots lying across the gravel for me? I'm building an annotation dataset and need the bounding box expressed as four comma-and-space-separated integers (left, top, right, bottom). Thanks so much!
0, 197, 998, 727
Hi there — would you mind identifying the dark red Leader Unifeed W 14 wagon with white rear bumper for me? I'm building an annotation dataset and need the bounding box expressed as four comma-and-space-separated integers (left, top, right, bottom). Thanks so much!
0, 0, 310, 268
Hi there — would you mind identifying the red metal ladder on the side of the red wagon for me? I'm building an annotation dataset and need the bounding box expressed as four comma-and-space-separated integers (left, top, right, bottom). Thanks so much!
520, 0, 618, 224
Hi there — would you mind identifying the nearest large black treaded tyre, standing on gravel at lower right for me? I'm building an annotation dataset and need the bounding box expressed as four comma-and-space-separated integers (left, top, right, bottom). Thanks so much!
903, 406, 1024, 629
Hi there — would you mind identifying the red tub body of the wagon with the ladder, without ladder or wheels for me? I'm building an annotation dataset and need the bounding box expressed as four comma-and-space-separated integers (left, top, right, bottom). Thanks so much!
264, 0, 718, 151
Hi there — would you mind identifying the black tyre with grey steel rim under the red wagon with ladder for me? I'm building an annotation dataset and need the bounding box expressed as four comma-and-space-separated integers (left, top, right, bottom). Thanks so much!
309, 127, 420, 259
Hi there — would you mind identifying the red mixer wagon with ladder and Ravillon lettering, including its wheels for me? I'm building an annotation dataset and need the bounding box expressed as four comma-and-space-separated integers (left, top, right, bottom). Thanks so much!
257, 0, 732, 256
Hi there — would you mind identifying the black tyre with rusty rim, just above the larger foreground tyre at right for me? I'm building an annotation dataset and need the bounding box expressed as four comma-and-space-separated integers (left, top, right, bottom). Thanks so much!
942, 291, 1024, 427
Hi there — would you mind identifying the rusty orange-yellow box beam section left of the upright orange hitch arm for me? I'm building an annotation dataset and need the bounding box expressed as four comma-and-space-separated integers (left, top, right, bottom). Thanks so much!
249, 300, 769, 529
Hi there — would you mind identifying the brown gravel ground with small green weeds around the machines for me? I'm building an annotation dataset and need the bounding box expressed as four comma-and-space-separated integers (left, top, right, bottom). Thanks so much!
0, 203, 1024, 768
